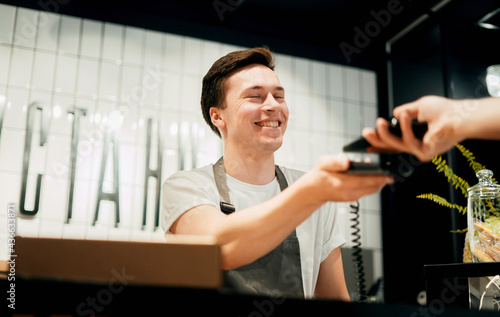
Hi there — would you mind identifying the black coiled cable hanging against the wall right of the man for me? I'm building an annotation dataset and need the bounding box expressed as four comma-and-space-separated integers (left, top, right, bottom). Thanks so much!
350, 201, 367, 302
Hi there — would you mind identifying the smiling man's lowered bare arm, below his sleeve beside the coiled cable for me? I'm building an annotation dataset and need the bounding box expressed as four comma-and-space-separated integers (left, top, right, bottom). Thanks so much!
314, 247, 351, 301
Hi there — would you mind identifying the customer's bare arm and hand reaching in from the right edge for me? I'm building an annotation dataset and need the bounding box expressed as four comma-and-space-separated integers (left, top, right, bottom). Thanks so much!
363, 96, 500, 161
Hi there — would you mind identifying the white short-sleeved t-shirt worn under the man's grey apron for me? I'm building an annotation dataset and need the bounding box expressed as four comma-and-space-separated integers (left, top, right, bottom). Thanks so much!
161, 164, 345, 298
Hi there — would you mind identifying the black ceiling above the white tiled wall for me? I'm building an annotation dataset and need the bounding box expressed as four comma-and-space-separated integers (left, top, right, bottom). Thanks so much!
0, 0, 498, 68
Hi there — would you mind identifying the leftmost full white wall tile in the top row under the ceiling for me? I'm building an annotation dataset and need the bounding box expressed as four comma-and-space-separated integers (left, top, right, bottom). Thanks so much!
13, 8, 38, 48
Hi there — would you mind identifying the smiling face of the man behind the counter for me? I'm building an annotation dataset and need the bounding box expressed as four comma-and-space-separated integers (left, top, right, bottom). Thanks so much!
221, 64, 288, 152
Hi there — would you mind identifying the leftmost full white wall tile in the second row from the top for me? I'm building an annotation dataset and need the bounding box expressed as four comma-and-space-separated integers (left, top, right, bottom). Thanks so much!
9, 48, 33, 88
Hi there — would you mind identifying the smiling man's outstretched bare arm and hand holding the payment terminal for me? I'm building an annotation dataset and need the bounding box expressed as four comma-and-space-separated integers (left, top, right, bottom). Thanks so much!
170, 156, 392, 269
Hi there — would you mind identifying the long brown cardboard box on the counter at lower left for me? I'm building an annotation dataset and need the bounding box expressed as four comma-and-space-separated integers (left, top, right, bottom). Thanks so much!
0, 236, 222, 288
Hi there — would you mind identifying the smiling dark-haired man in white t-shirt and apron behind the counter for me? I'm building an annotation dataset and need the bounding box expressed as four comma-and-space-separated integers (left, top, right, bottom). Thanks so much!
162, 48, 393, 301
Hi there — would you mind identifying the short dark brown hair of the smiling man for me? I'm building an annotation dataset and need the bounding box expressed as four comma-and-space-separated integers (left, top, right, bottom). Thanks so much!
201, 47, 274, 137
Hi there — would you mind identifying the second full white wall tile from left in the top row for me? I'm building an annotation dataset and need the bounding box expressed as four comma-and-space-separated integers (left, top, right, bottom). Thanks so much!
36, 11, 61, 52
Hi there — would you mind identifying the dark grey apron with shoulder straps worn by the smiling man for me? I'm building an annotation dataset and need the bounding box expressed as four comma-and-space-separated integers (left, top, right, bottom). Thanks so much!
213, 157, 304, 298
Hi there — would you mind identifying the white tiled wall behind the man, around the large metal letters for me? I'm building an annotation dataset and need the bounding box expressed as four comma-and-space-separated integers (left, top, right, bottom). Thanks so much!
0, 4, 382, 275
